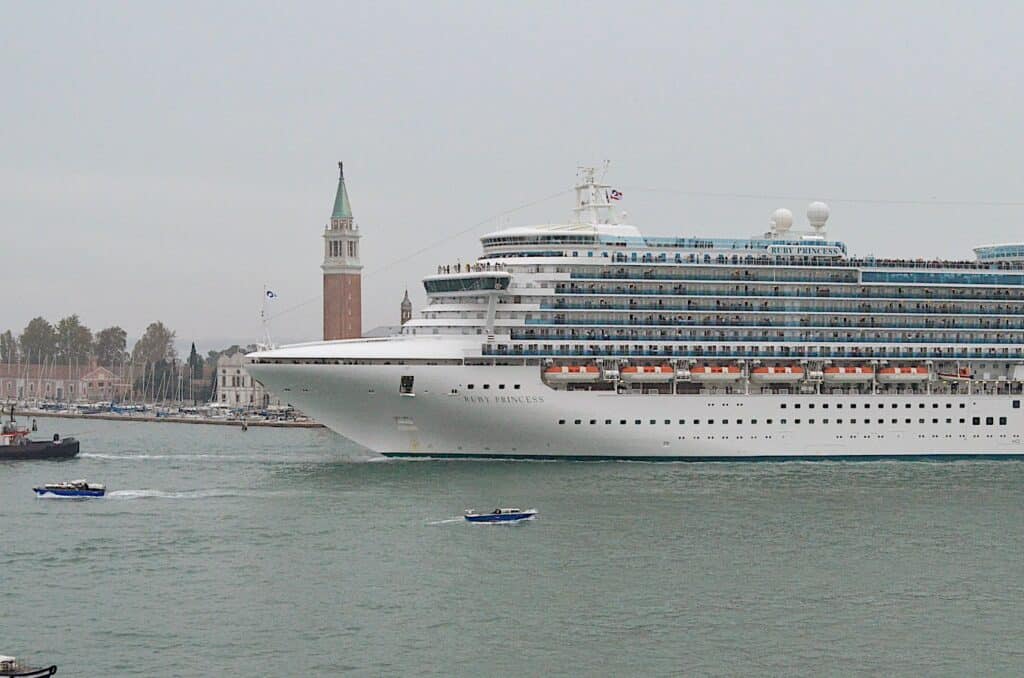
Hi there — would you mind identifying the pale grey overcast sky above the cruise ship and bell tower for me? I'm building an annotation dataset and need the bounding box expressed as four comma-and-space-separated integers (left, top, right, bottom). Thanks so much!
0, 0, 1024, 351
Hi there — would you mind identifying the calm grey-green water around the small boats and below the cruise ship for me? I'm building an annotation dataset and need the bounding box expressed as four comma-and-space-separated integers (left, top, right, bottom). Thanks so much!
0, 420, 1024, 676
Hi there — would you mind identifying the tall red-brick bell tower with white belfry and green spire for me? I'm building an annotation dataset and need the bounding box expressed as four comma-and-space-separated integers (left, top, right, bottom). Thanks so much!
321, 163, 362, 341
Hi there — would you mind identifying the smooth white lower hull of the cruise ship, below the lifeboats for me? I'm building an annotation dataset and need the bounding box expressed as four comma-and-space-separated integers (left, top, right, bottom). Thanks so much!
251, 365, 1024, 461
